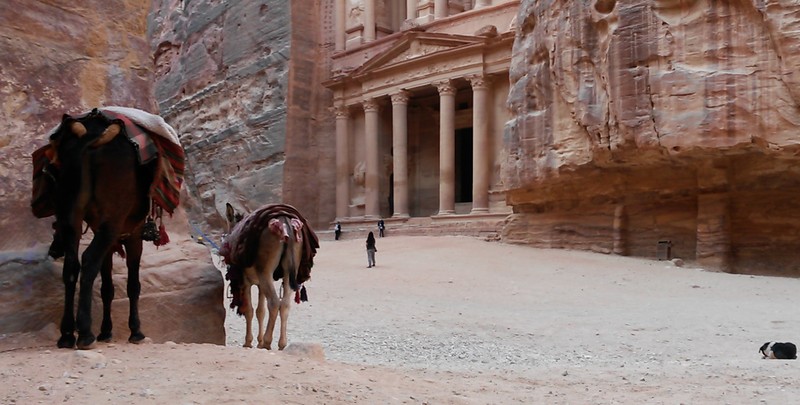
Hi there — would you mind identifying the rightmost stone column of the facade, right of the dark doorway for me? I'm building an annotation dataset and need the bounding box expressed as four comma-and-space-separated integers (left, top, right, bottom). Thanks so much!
467, 75, 491, 214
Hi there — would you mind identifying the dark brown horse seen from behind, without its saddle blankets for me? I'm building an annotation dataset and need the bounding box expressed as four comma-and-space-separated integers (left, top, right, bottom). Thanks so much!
50, 109, 157, 349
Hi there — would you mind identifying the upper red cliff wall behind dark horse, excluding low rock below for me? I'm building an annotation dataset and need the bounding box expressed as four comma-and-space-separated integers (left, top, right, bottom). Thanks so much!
0, 0, 154, 249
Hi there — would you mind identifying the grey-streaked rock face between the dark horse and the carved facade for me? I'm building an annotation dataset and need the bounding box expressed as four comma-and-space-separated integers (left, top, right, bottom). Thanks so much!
148, 0, 335, 234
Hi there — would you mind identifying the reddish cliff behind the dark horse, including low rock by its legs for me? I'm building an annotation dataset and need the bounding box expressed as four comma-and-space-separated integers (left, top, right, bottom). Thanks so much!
0, 0, 225, 340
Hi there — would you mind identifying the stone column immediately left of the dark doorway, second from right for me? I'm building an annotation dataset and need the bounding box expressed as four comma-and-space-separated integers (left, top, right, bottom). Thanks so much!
434, 80, 456, 215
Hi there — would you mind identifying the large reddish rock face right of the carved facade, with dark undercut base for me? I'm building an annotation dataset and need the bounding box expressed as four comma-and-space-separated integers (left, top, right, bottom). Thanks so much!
510, 0, 800, 275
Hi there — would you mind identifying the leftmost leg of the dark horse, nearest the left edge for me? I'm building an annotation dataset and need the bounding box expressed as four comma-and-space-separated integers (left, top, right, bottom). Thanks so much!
57, 227, 81, 349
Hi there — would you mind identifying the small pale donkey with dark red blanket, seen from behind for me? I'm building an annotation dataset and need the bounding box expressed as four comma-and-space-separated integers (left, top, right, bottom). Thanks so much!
220, 203, 319, 350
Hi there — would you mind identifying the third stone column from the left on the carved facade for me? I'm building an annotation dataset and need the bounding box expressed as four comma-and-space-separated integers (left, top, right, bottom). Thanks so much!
392, 90, 410, 218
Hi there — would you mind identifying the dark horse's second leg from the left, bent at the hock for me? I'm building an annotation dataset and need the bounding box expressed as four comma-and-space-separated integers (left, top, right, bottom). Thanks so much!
77, 224, 118, 349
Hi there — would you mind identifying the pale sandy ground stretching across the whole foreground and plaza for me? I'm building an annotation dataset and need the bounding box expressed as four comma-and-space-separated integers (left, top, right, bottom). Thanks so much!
0, 237, 800, 404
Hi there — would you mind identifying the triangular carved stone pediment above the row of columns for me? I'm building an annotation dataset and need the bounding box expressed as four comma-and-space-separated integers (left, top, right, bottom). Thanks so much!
353, 32, 485, 76
